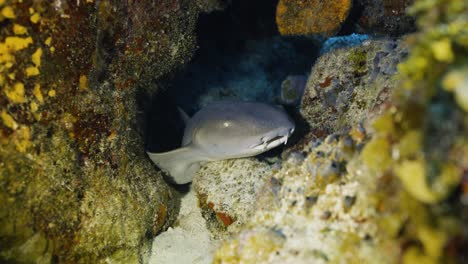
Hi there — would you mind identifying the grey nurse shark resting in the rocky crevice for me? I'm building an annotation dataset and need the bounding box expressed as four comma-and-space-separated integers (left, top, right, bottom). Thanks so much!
147, 100, 294, 184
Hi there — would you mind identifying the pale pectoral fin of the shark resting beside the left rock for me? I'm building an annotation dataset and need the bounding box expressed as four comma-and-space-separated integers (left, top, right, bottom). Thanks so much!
146, 147, 203, 184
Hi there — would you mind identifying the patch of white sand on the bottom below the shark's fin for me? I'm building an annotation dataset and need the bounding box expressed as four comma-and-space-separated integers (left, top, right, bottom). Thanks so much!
149, 190, 219, 264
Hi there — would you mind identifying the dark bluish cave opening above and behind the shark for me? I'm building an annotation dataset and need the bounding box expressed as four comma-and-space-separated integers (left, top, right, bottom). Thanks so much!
146, 0, 319, 159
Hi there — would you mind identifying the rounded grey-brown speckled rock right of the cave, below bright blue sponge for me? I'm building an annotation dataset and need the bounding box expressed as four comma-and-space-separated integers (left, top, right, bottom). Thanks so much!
300, 40, 407, 140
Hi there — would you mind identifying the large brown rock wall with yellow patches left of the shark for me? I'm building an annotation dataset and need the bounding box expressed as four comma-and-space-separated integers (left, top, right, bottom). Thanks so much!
0, 1, 201, 263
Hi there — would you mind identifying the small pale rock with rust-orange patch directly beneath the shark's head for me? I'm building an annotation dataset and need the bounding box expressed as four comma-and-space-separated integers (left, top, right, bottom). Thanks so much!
193, 158, 272, 237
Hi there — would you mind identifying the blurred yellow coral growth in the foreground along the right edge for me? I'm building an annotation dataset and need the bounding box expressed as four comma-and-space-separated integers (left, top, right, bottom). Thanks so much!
362, 0, 468, 263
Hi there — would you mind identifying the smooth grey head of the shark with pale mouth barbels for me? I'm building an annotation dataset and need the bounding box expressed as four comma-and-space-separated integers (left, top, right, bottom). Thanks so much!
183, 101, 294, 160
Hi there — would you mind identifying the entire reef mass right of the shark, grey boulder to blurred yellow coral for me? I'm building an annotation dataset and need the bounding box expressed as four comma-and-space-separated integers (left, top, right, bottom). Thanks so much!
215, 0, 468, 263
